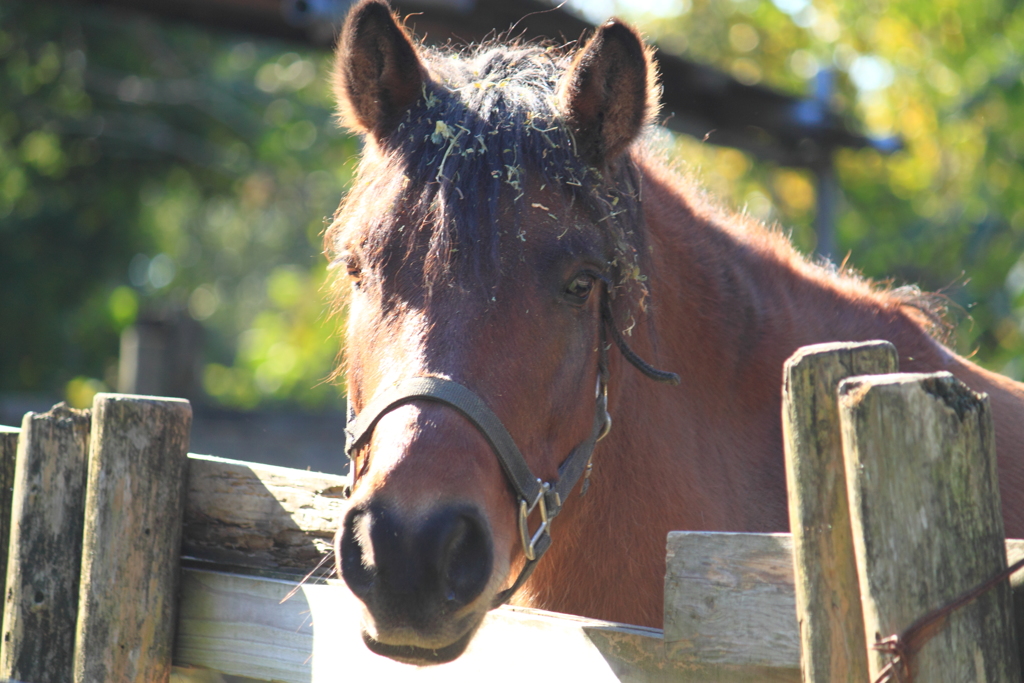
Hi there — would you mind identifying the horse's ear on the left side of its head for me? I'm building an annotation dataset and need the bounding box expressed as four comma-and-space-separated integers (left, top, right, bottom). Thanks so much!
334, 0, 425, 139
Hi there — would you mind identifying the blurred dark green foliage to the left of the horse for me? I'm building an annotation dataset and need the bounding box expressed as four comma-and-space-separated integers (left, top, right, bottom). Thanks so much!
0, 0, 357, 408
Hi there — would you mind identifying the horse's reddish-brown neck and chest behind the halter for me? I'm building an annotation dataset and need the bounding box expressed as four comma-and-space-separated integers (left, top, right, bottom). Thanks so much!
524, 156, 950, 625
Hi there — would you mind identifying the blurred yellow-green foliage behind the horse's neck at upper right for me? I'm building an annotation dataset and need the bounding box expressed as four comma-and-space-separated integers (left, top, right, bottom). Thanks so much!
602, 0, 1024, 379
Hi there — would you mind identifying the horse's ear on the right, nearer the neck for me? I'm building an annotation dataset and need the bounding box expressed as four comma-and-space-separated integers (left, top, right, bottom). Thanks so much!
559, 19, 657, 166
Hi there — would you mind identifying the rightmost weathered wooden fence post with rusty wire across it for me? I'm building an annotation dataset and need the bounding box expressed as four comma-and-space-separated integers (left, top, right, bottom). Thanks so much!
839, 373, 1021, 683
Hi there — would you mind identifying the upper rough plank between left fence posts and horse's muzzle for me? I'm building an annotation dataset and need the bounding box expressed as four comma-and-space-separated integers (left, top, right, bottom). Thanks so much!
182, 455, 347, 574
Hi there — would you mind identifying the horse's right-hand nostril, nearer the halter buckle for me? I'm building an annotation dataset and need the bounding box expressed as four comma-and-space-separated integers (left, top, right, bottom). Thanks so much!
431, 509, 492, 607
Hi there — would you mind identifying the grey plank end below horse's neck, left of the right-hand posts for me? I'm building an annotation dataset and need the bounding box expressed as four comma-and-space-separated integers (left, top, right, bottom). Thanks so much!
665, 531, 800, 680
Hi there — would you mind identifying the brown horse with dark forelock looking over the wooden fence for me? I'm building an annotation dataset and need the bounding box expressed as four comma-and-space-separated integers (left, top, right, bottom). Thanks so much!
327, 0, 1024, 663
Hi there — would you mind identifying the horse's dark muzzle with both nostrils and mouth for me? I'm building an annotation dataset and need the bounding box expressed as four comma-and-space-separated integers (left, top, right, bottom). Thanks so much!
336, 500, 494, 664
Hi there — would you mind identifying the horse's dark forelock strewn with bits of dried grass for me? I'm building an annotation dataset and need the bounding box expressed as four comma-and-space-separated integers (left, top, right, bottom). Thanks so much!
328, 44, 645, 296
